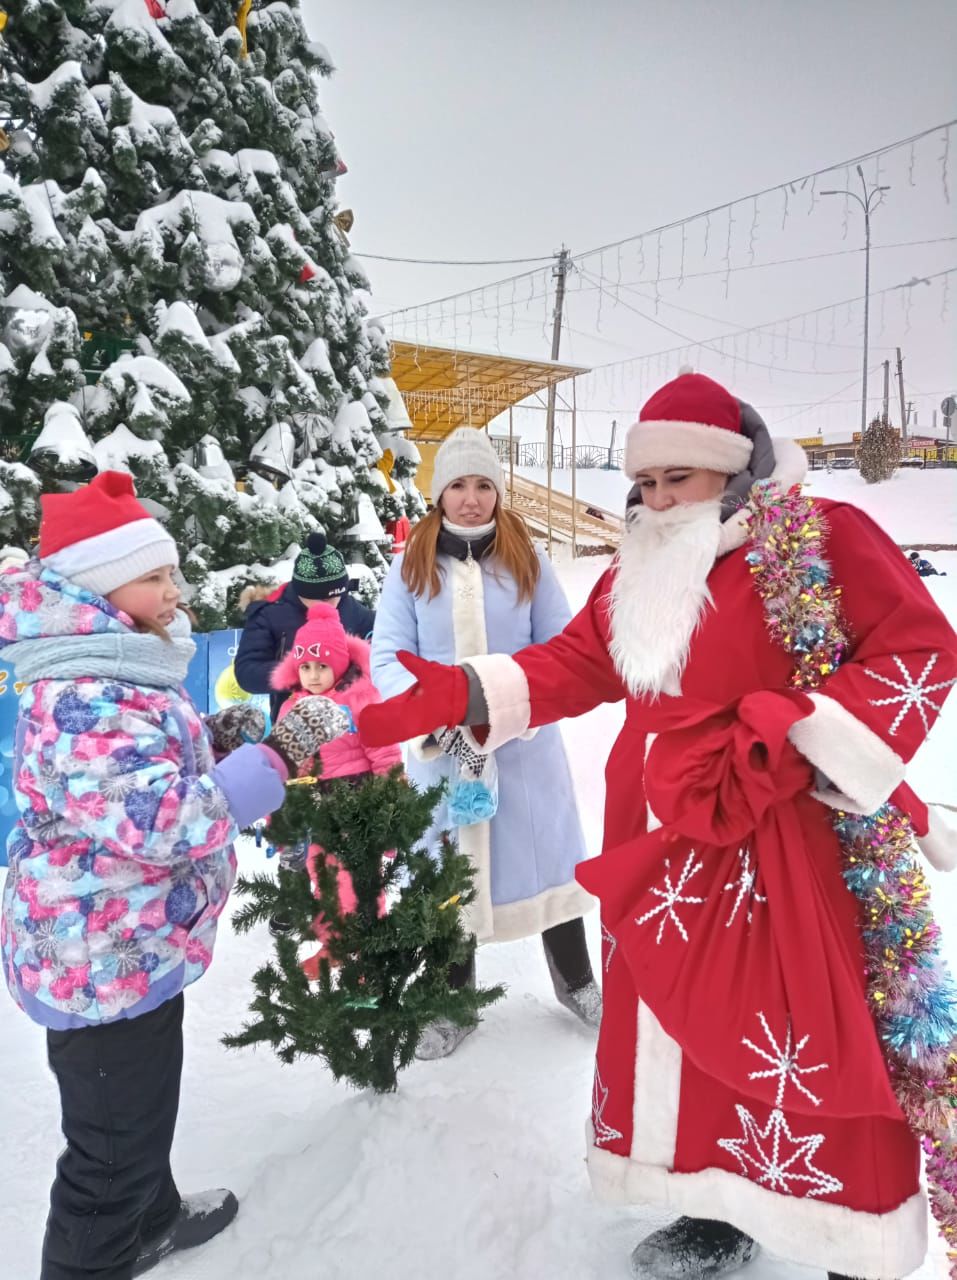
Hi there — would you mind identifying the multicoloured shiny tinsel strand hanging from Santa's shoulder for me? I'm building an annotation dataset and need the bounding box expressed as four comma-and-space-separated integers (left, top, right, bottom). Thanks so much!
747, 481, 957, 1280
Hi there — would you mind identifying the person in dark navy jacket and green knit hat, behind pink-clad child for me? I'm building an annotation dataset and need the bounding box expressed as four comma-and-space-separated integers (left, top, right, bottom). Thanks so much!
235, 532, 375, 722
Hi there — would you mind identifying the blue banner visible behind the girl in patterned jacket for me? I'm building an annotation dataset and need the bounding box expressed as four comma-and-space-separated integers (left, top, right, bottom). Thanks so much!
0, 630, 269, 867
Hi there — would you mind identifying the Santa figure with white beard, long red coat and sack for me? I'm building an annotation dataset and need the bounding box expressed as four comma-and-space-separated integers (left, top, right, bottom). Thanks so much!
360, 374, 957, 1280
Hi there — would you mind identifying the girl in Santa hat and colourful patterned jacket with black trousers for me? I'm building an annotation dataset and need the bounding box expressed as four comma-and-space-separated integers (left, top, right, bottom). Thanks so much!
0, 472, 347, 1280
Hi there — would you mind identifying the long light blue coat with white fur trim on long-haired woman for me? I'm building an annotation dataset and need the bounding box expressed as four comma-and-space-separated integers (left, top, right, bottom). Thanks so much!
372, 554, 592, 942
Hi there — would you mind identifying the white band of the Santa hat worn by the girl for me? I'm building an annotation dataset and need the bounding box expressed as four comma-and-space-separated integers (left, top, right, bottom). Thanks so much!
42, 520, 179, 595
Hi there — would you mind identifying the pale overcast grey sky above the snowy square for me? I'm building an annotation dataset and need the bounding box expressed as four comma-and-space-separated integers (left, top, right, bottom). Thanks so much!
303, 0, 957, 440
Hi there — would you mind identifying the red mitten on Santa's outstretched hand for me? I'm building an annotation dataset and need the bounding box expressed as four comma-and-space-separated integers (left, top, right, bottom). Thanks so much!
358, 649, 468, 746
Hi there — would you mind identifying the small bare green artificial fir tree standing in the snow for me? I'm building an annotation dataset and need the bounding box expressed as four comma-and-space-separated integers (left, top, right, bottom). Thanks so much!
225, 769, 503, 1093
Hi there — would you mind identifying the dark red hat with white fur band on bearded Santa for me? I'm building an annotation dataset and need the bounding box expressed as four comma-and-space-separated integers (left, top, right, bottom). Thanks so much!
623, 370, 752, 480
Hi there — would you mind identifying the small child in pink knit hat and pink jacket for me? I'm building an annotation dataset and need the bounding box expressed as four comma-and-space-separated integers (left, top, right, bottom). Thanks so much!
270, 604, 402, 977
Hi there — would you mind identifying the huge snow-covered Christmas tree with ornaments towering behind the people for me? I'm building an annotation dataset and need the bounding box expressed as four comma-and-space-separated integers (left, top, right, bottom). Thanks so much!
0, 0, 421, 627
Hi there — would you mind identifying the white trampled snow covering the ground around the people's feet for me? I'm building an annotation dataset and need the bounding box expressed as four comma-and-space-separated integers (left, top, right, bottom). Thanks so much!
0, 550, 957, 1280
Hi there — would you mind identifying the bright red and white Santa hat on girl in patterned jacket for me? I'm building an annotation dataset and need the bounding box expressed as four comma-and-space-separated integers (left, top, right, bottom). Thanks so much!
38, 471, 179, 595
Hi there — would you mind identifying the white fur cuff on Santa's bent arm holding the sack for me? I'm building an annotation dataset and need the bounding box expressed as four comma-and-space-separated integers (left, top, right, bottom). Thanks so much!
788, 694, 905, 814
